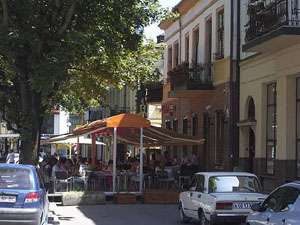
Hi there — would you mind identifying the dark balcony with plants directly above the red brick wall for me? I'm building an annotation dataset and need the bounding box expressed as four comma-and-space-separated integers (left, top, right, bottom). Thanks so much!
168, 63, 213, 91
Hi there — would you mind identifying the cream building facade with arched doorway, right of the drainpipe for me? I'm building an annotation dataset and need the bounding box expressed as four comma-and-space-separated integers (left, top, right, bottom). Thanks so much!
239, 0, 300, 190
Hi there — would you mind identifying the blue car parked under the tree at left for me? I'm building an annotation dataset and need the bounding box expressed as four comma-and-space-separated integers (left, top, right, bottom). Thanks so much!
0, 163, 49, 225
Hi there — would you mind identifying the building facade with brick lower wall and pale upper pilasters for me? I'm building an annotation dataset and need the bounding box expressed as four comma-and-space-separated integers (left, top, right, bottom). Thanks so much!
160, 0, 238, 170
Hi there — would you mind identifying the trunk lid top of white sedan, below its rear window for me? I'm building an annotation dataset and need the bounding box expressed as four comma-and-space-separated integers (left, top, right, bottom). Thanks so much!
210, 192, 267, 202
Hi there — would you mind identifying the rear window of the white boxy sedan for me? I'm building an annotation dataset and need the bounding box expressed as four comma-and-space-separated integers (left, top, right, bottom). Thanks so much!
209, 176, 260, 193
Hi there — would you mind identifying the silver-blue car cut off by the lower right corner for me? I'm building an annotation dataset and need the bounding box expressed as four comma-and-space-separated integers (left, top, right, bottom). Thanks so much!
247, 182, 300, 225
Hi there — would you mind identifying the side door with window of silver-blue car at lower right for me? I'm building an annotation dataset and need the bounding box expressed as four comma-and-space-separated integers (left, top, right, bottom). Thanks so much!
269, 186, 300, 225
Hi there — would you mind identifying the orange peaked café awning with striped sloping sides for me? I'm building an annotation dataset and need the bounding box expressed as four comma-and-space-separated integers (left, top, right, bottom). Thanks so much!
73, 114, 204, 147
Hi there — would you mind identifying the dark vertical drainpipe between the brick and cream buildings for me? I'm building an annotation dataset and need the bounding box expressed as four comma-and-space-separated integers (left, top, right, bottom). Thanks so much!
229, 0, 240, 169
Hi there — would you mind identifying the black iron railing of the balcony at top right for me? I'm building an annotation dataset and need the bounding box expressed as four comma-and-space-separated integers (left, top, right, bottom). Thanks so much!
245, 0, 300, 43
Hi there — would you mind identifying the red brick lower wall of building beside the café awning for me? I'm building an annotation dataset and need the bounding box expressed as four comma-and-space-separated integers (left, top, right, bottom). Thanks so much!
162, 84, 231, 170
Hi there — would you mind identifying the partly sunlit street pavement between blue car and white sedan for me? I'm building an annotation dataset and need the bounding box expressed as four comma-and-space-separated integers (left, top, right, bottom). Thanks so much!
56, 204, 180, 225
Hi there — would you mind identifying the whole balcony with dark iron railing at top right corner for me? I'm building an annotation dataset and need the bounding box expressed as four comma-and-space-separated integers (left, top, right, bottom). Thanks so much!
243, 0, 300, 53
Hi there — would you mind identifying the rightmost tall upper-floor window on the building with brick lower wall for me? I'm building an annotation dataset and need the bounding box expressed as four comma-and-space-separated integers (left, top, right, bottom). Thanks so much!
216, 9, 224, 60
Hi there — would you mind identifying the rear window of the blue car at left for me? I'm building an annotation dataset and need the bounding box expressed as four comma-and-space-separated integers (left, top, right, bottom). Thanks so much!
0, 168, 33, 190
